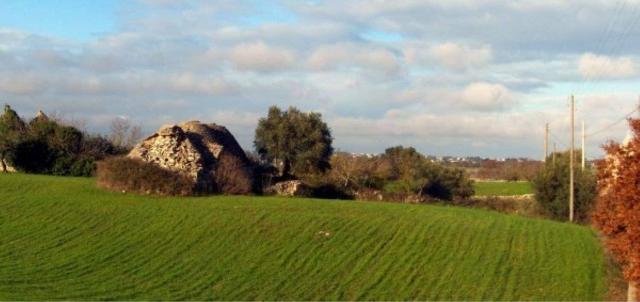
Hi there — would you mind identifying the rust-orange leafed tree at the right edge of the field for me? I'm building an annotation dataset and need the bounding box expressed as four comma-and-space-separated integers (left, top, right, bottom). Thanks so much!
592, 119, 640, 301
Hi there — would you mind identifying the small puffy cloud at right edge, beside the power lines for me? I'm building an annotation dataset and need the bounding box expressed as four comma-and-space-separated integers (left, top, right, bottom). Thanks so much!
578, 53, 638, 79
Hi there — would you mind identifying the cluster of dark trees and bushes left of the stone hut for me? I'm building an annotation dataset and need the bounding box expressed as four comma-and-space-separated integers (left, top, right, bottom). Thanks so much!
0, 105, 139, 176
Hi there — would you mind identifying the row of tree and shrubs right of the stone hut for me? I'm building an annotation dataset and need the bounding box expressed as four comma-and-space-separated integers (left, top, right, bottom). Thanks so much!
255, 106, 473, 200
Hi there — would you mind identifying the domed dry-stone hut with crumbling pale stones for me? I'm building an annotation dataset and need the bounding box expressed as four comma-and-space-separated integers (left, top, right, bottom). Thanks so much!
128, 121, 254, 194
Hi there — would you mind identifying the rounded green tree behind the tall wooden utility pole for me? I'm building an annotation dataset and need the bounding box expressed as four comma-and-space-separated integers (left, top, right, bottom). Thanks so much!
533, 151, 596, 221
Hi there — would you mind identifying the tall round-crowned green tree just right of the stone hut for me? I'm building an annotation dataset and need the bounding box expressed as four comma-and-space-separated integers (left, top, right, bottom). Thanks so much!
254, 106, 333, 177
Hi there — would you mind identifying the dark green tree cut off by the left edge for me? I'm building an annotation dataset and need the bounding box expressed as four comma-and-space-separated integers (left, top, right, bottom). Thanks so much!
0, 105, 26, 172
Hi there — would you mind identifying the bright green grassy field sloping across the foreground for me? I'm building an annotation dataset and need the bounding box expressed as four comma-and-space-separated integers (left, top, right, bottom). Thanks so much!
0, 175, 605, 300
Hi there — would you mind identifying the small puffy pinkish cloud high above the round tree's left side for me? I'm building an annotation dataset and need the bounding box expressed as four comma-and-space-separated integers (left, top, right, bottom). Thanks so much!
229, 42, 296, 71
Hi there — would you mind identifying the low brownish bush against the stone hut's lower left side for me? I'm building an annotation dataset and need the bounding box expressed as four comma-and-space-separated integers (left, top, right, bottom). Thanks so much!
96, 157, 196, 196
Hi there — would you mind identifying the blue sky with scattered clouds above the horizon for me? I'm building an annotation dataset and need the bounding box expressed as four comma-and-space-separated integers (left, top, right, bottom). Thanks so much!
0, 0, 640, 159
